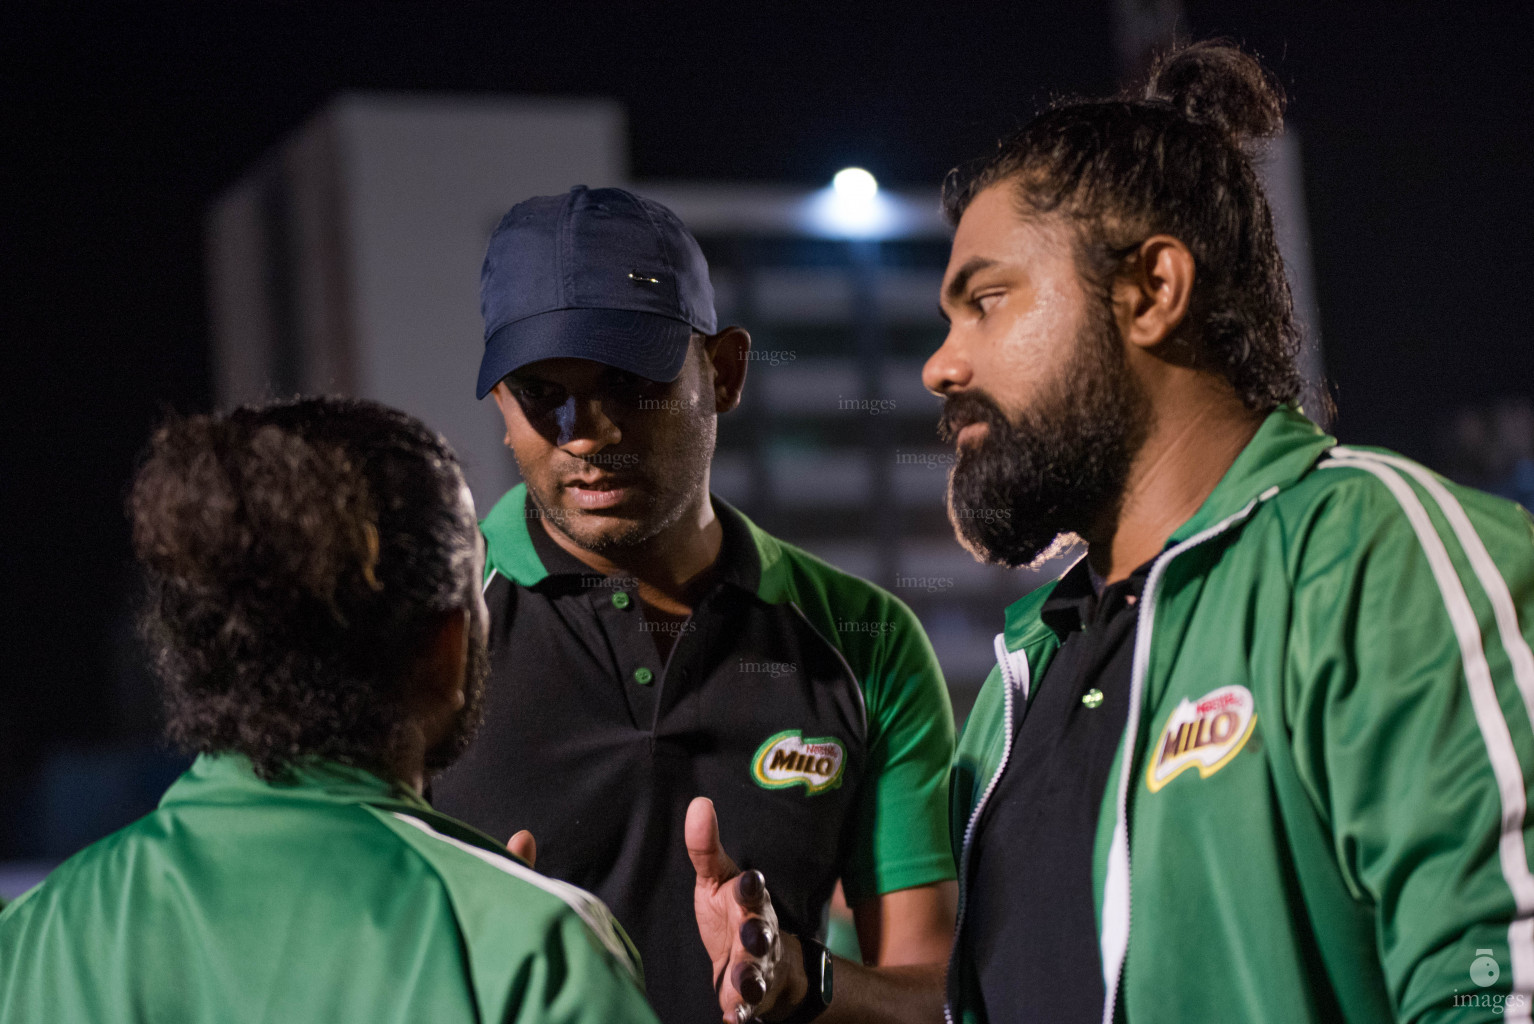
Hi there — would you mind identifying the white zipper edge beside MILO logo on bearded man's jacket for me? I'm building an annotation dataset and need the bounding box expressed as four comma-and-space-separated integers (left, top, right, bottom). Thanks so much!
1098, 487, 1278, 1024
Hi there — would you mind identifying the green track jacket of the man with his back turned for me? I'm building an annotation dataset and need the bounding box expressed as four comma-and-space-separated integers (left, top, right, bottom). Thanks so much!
0, 754, 655, 1024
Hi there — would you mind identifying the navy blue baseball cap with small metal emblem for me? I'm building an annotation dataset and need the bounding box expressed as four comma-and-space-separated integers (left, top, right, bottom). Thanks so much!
477, 185, 719, 399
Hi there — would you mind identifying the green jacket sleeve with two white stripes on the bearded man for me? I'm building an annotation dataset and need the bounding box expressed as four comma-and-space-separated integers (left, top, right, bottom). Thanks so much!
1285, 471, 1534, 1021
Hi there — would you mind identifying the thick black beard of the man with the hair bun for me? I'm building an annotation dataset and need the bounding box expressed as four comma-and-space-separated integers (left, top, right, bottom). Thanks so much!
937, 308, 1151, 569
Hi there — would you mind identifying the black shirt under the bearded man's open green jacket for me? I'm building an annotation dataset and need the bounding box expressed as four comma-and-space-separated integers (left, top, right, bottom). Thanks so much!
963, 558, 1151, 1024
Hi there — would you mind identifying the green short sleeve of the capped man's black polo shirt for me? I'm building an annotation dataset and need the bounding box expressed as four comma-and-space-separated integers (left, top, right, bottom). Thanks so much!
842, 593, 954, 906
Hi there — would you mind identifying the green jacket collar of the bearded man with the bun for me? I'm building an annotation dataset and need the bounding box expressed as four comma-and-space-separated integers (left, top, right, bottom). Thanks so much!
1005, 405, 1336, 650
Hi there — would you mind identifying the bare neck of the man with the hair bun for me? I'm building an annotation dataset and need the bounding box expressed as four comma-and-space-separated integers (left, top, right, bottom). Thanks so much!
1086, 374, 1262, 583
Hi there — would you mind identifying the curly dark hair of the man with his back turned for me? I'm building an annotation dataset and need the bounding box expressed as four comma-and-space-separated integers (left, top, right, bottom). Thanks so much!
127, 399, 477, 779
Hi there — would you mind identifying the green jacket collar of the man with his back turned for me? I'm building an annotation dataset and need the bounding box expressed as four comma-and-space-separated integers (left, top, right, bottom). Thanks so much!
160, 753, 431, 811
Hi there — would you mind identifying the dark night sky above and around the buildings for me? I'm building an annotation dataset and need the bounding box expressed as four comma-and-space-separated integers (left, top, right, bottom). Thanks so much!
0, 0, 1534, 772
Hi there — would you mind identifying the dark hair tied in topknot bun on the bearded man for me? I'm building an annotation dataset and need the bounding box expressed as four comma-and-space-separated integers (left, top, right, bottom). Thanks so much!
943, 41, 1301, 411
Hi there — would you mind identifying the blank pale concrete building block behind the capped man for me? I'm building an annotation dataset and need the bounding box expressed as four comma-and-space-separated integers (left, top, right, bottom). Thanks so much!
207, 94, 627, 510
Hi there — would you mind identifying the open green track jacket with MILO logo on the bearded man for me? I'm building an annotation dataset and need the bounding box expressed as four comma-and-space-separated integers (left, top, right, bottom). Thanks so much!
948, 408, 1534, 1024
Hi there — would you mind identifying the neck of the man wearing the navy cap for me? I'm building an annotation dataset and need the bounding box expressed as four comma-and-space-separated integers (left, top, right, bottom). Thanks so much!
543, 480, 724, 615
